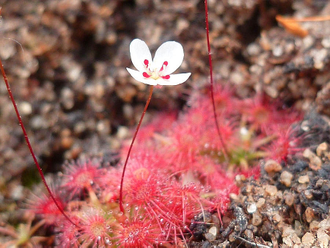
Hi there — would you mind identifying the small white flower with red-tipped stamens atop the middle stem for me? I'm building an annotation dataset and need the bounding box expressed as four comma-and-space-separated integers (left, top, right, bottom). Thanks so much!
126, 39, 191, 85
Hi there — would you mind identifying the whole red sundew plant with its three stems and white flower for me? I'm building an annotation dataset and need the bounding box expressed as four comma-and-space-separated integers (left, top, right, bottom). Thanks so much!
0, 1, 301, 247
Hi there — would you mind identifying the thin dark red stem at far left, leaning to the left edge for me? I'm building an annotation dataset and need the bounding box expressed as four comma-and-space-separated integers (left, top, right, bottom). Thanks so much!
0, 59, 77, 226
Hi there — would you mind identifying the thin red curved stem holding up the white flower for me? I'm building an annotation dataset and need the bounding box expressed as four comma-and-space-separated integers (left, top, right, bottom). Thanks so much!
119, 85, 154, 213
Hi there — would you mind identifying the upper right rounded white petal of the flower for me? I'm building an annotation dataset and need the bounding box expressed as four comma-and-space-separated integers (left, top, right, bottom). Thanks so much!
153, 41, 184, 75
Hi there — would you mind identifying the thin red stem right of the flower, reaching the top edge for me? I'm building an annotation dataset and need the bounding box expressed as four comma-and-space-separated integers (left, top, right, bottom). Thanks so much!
204, 0, 229, 161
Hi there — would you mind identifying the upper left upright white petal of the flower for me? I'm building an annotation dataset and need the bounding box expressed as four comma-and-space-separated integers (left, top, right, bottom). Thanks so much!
129, 39, 152, 71
